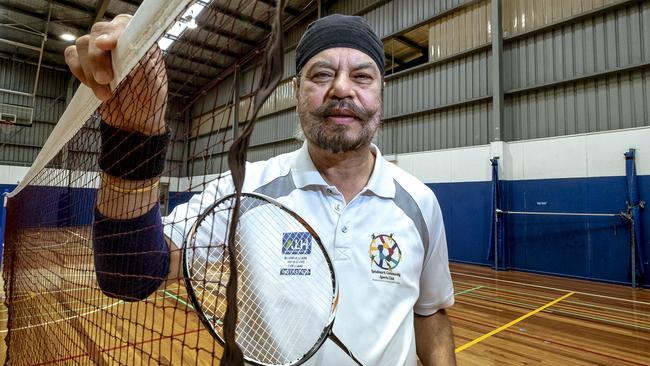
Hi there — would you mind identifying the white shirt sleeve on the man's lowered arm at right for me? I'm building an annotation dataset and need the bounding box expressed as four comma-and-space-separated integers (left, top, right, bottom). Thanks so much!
413, 196, 454, 316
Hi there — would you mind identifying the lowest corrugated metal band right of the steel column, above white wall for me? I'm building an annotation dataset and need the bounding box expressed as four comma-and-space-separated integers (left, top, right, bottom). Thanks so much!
504, 68, 650, 141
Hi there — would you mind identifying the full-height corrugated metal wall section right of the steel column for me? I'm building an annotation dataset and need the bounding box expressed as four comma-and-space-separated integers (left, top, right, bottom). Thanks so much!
503, 1, 650, 141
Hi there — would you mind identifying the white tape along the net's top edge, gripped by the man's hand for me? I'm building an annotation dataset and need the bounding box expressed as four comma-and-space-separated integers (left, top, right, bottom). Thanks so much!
8, 0, 192, 198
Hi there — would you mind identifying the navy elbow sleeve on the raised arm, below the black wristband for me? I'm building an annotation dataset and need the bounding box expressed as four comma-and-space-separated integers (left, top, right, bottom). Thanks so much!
93, 204, 169, 301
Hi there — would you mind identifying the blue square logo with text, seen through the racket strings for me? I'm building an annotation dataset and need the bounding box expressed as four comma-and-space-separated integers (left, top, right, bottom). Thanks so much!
280, 232, 313, 276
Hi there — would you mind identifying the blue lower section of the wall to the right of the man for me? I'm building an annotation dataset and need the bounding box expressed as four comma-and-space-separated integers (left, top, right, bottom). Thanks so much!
429, 176, 650, 286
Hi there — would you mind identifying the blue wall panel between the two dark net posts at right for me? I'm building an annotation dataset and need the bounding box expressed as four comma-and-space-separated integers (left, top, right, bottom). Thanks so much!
504, 177, 629, 282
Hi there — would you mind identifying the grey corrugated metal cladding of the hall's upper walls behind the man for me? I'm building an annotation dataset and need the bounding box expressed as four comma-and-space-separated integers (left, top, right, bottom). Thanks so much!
6, 0, 650, 175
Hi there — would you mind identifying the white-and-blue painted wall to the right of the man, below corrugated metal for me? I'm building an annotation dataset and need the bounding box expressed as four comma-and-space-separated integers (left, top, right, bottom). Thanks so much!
387, 127, 650, 285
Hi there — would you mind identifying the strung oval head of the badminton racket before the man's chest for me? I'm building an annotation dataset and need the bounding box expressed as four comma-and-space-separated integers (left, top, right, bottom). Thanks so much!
182, 193, 338, 365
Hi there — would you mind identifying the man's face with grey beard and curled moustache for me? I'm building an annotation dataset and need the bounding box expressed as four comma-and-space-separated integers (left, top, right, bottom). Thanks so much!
297, 48, 383, 153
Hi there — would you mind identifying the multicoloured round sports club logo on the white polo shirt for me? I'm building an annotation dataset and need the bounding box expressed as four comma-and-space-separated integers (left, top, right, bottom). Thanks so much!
368, 234, 402, 283
